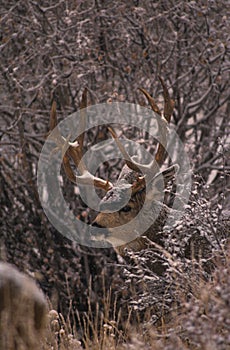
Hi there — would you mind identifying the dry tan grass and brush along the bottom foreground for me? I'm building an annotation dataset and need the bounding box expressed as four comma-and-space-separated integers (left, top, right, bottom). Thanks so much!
5, 243, 225, 350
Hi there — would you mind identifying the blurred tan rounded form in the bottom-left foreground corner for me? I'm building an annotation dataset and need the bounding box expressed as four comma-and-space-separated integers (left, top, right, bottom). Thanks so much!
0, 262, 47, 350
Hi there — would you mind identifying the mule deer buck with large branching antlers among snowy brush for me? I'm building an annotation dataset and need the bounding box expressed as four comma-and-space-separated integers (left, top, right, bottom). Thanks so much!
50, 78, 179, 256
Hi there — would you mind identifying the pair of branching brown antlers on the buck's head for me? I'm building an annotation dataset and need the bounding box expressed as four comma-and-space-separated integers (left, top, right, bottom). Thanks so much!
50, 77, 174, 191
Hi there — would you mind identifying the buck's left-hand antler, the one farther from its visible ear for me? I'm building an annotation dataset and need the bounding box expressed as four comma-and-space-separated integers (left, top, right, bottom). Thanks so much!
50, 89, 113, 191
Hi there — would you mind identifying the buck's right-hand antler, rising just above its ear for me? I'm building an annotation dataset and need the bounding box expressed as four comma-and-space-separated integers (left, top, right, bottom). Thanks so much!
108, 77, 174, 175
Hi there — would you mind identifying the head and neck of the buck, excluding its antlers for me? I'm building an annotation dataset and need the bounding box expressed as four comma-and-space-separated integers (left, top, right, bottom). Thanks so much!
92, 165, 175, 256
